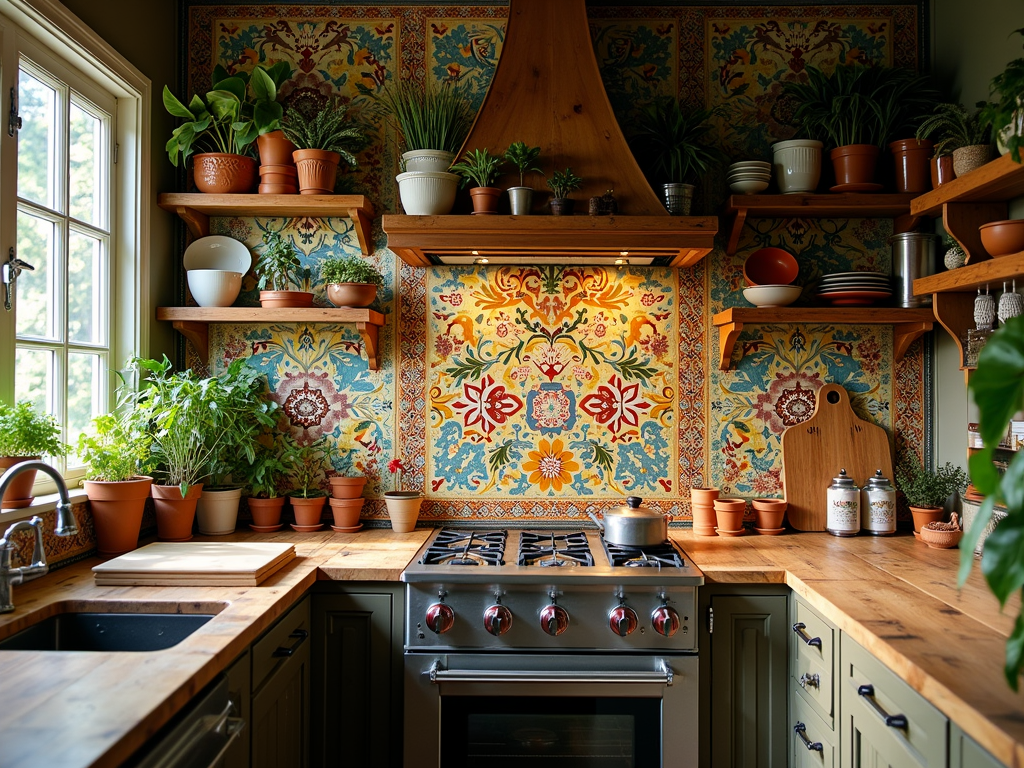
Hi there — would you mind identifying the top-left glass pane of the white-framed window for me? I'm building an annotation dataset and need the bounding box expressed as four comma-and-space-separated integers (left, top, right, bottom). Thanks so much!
17, 71, 57, 209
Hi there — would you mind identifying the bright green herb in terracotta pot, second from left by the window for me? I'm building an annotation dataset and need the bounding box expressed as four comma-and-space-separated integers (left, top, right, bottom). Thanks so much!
78, 412, 153, 557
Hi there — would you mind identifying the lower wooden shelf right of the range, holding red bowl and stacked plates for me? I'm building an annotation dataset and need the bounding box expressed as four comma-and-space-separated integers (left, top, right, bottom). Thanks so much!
713, 306, 934, 371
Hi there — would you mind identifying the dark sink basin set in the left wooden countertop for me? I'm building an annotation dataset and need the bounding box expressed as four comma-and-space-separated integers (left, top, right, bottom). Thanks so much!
0, 611, 215, 651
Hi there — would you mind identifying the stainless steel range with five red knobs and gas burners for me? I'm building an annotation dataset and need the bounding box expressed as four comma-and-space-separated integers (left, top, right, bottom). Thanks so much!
401, 528, 703, 768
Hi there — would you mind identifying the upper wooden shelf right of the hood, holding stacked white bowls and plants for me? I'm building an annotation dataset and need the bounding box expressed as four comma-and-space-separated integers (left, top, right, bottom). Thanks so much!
722, 193, 918, 256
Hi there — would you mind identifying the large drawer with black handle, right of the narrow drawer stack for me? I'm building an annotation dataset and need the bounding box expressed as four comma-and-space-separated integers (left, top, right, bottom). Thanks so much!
840, 634, 948, 768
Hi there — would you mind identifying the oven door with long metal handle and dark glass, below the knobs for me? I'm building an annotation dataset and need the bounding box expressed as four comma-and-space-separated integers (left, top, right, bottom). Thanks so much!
404, 653, 697, 768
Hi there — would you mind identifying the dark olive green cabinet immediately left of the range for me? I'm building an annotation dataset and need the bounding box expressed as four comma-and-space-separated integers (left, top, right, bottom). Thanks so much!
311, 582, 404, 768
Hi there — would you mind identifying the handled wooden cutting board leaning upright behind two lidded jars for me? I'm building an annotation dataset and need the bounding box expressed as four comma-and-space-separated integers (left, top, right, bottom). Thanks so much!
782, 384, 893, 530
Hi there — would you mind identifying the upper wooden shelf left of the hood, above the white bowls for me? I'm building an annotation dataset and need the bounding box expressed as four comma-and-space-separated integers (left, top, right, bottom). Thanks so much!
158, 193, 374, 256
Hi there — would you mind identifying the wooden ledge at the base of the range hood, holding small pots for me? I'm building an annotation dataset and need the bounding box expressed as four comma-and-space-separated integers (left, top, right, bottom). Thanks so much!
383, 215, 718, 267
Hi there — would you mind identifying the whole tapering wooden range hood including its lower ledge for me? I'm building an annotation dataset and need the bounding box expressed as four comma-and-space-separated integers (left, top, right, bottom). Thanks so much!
383, 0, 718, 266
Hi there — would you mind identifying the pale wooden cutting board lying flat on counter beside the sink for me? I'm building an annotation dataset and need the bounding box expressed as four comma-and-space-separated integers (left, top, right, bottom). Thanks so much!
92, 542, 295, 587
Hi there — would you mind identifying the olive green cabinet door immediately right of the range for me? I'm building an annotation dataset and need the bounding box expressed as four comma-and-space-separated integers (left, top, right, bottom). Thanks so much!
711, 595, 790, 768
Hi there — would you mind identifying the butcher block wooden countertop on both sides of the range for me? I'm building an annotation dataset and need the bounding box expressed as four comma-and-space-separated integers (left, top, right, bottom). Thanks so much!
0, 528, 1024, 768
